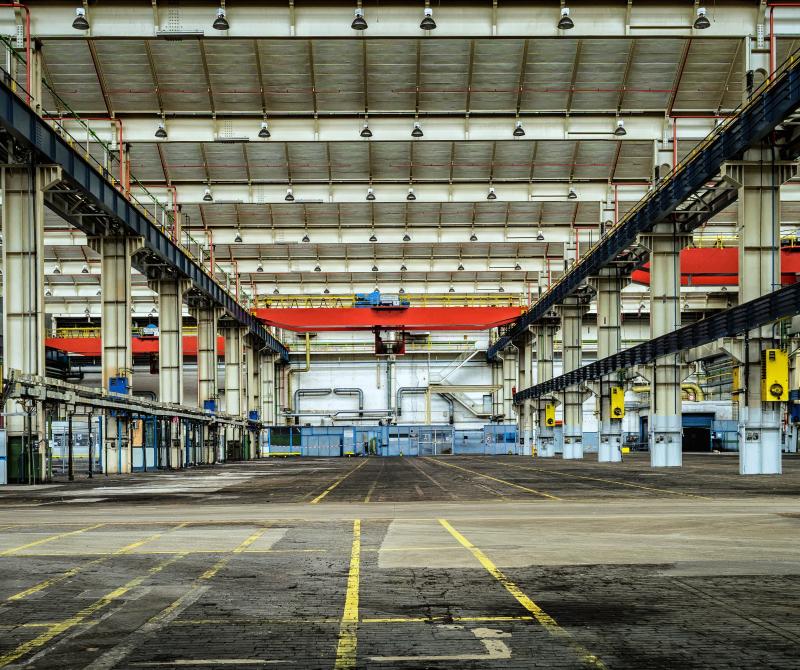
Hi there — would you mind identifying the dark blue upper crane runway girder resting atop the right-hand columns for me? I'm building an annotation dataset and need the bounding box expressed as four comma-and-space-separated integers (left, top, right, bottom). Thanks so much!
486, 50, 800, 361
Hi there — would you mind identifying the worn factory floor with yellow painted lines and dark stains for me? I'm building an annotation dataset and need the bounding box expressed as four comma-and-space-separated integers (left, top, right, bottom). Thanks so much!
0, 455, 800, 669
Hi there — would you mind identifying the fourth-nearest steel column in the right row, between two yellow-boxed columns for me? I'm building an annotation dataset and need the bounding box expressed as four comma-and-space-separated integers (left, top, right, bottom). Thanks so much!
558, 298, 586, 459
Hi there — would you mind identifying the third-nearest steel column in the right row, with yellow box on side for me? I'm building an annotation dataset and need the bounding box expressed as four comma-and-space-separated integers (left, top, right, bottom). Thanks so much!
591, 266, 628, 463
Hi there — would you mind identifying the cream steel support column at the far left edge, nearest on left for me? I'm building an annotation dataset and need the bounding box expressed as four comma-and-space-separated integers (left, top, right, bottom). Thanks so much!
2, 165, 61, 483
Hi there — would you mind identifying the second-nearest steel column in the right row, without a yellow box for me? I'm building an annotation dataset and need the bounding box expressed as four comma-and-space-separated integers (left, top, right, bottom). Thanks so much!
642, 223, 691, 467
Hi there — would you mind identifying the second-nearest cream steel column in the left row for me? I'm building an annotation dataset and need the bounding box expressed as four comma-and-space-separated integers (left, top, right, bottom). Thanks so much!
89, 237, 142, 474
